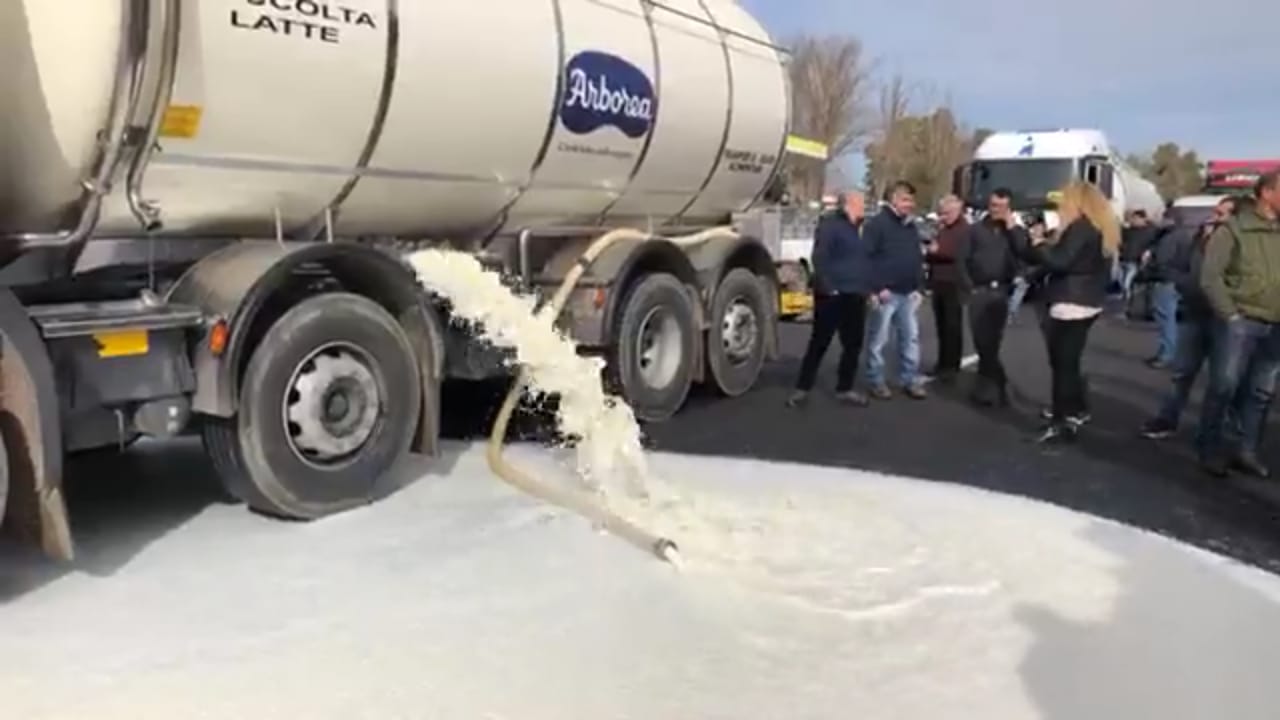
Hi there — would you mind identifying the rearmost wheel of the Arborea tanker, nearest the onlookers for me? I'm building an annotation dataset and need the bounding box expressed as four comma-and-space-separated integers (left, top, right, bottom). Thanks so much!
707, 268, 769, 397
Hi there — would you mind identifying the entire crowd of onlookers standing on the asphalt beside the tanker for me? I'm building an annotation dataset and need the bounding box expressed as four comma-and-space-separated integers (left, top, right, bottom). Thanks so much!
788, 172, 1280, 477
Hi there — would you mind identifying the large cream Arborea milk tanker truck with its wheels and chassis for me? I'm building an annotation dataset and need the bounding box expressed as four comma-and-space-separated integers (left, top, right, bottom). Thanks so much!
0, 0, 790, 559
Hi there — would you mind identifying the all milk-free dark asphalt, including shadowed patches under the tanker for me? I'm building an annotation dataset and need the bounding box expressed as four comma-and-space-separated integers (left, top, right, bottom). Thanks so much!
0, 294, 1280, 603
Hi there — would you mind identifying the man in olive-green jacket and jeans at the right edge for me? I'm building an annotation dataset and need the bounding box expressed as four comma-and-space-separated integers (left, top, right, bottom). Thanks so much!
1199, 170, 1280, 477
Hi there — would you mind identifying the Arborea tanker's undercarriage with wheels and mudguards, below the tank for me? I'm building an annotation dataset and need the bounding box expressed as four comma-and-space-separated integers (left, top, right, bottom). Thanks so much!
0, 228, 778, 560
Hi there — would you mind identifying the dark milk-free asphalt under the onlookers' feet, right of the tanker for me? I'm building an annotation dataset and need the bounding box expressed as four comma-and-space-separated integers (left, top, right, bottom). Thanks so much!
648, 299, 1280, 571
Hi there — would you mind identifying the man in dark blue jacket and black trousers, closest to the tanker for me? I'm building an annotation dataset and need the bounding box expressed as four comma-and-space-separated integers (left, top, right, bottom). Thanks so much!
787, 192, 872, 407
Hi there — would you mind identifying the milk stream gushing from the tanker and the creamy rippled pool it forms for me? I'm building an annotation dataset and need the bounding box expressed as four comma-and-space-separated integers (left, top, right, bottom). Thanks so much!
408, 250, 1013, 618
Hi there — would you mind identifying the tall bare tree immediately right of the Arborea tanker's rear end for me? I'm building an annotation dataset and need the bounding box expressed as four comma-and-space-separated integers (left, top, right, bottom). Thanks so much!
790, 35, 870, 200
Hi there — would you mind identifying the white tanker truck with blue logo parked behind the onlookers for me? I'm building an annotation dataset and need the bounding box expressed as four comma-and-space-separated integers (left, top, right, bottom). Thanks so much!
952, 128, 1165, 228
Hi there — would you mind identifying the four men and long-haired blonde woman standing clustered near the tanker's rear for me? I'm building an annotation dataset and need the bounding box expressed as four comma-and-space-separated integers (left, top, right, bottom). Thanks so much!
788, 174, 1126, 442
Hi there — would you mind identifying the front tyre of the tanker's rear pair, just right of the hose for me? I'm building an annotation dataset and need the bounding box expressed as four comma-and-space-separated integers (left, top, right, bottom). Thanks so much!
609, 273, 698, 423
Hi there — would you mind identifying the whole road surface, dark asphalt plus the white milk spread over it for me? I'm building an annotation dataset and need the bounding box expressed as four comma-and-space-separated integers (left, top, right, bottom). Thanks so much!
0, 297, 1280, 720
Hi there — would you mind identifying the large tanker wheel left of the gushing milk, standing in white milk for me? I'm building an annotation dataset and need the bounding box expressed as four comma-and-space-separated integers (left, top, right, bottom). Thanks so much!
204, 293, 422, 520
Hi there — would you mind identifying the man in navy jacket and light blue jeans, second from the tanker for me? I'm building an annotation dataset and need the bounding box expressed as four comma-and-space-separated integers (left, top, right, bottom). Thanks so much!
865, 181, 927, 400
